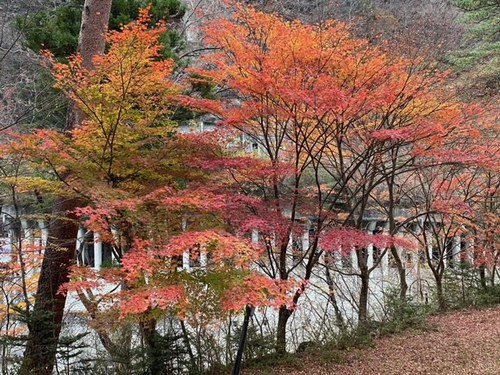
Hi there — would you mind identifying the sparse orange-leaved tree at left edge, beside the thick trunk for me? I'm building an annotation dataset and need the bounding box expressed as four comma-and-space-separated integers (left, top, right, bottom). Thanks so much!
0, 150, 45, 373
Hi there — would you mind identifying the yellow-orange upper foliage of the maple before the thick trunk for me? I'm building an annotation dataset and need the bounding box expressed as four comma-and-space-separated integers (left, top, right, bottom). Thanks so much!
27, 9, 185, 196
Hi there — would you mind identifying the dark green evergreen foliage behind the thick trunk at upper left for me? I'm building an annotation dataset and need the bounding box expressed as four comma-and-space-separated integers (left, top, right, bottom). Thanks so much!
15, 0, 188, 129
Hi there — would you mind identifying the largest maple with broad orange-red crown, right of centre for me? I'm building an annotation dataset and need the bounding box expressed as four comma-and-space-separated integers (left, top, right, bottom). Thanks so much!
188, 1, 434, 351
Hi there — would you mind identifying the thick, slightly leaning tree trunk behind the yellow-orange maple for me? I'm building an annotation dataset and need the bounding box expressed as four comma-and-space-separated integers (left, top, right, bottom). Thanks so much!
19, 0, 111, 375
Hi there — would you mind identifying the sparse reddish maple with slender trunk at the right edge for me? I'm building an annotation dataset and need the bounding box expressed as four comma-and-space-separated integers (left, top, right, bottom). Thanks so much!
392, 101, 498, 309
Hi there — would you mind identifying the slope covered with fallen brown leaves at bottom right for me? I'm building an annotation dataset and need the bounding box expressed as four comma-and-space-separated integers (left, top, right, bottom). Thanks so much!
244, 307, 500, 375
